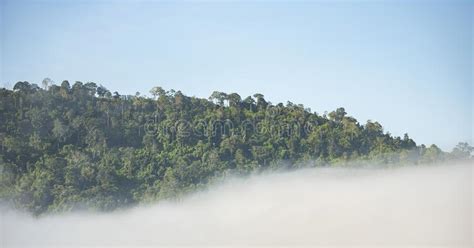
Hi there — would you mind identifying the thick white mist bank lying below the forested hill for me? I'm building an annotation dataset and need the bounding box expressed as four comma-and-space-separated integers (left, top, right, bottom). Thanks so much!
0, 164, 474, 247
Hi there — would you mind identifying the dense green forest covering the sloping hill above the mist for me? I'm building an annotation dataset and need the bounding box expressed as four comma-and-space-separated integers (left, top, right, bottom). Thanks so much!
0, 79, 472, 214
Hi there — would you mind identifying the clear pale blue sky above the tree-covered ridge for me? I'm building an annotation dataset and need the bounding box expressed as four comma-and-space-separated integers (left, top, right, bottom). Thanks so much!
0, 0, 474, 150
